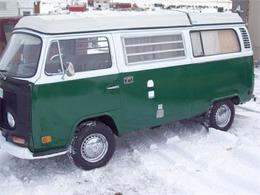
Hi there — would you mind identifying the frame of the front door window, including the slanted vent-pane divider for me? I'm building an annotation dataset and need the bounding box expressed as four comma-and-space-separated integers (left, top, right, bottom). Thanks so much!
43, 34, 114, 77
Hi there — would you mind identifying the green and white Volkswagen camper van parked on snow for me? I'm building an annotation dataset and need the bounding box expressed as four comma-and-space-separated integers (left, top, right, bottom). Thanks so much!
0, 11, 254, 170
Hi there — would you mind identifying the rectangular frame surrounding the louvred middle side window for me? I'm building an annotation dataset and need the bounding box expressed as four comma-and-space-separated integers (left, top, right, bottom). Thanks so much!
121, 31, 187, 66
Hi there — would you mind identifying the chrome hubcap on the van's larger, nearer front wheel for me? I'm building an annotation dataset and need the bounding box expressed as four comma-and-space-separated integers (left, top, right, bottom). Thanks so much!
81, 133, 108, 163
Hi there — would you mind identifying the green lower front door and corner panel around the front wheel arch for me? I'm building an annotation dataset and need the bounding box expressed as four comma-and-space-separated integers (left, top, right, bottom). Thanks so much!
30, 75, 120, 152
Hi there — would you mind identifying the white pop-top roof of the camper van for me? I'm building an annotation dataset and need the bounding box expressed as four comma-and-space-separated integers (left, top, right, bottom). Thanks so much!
16, 11, 243, 34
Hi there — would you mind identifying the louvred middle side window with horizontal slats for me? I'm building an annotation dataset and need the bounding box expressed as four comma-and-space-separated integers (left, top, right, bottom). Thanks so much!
123, 34, 185, 65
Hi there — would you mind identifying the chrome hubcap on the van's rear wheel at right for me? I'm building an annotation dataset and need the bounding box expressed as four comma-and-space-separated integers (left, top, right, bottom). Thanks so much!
216, 104, 231, 128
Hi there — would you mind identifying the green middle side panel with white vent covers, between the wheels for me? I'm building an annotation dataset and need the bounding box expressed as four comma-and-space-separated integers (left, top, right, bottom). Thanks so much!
121, 62, 192, 132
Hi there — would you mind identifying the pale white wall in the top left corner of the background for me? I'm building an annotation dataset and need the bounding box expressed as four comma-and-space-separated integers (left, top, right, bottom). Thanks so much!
0, 0, 18, 17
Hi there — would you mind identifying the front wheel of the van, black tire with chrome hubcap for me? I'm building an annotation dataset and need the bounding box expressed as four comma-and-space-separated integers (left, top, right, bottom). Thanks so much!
70, 122, 115, 170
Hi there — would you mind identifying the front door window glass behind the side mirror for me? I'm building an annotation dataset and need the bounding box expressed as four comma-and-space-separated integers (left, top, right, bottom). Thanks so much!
45, 37, 112, 74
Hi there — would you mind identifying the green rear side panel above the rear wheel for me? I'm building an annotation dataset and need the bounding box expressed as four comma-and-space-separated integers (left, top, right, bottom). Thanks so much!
191, 57, 254, 116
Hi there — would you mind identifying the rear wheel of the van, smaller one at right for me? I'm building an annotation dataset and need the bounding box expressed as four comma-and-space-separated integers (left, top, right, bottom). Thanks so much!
209, 100, 235, 131
